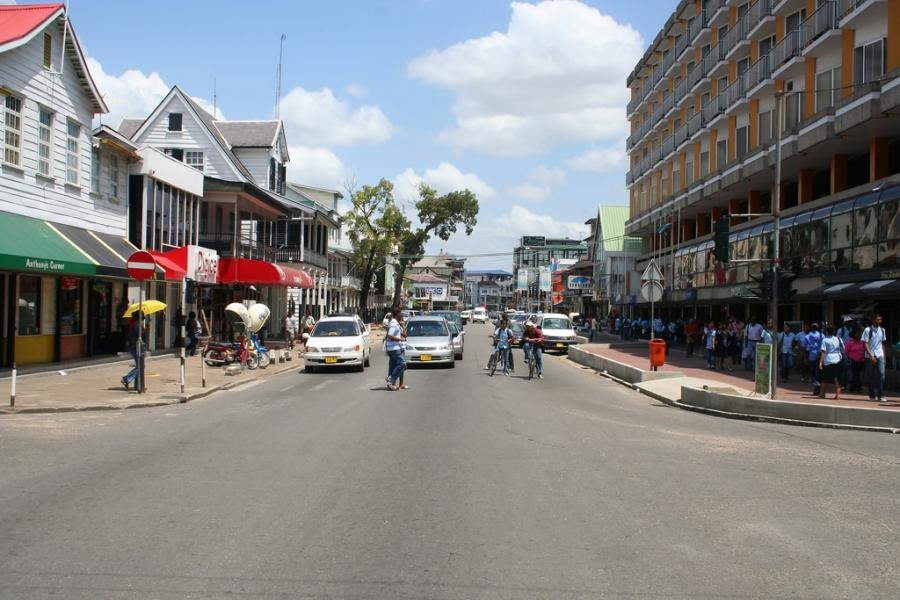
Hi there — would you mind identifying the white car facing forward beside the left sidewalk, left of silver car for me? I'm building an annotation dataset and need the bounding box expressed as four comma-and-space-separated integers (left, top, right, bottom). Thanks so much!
303, 315, 372, 373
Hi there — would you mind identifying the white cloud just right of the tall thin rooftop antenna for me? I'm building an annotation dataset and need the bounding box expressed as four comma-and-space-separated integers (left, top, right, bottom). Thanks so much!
281, 87, 394, 148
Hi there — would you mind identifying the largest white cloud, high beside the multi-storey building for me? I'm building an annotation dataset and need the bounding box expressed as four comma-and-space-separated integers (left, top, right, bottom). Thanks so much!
407, 0, 643, 156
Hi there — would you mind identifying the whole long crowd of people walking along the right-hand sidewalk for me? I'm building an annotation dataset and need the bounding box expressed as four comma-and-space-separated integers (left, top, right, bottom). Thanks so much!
608, 314, 890, 402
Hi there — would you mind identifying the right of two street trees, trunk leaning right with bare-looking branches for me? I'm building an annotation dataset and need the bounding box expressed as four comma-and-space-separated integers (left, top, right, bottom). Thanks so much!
393, 183, 478, 306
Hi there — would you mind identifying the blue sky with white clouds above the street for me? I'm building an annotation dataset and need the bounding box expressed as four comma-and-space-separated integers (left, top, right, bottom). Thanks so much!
56, 0, 677, 271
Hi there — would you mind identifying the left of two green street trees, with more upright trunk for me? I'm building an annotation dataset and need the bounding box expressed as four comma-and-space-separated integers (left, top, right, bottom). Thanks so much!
344, 178, 410, 306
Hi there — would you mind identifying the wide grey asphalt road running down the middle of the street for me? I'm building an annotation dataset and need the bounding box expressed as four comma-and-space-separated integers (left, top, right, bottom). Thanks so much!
0, 326, 900, 599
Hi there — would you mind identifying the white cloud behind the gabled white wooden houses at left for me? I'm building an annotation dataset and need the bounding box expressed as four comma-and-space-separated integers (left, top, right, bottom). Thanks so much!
87, 58, 225, 128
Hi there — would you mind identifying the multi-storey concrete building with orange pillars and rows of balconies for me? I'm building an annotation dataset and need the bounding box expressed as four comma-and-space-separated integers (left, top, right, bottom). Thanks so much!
626, 0, 900, 323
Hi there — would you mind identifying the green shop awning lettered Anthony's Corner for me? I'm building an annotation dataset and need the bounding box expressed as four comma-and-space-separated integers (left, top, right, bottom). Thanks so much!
0, 212, 97, 275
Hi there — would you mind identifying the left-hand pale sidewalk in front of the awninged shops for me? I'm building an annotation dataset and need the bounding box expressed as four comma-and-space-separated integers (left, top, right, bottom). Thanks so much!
0, 349, 303, 415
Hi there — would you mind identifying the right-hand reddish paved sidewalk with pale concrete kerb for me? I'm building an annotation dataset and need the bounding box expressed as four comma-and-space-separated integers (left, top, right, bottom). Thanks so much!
573, 334, 900, 431
